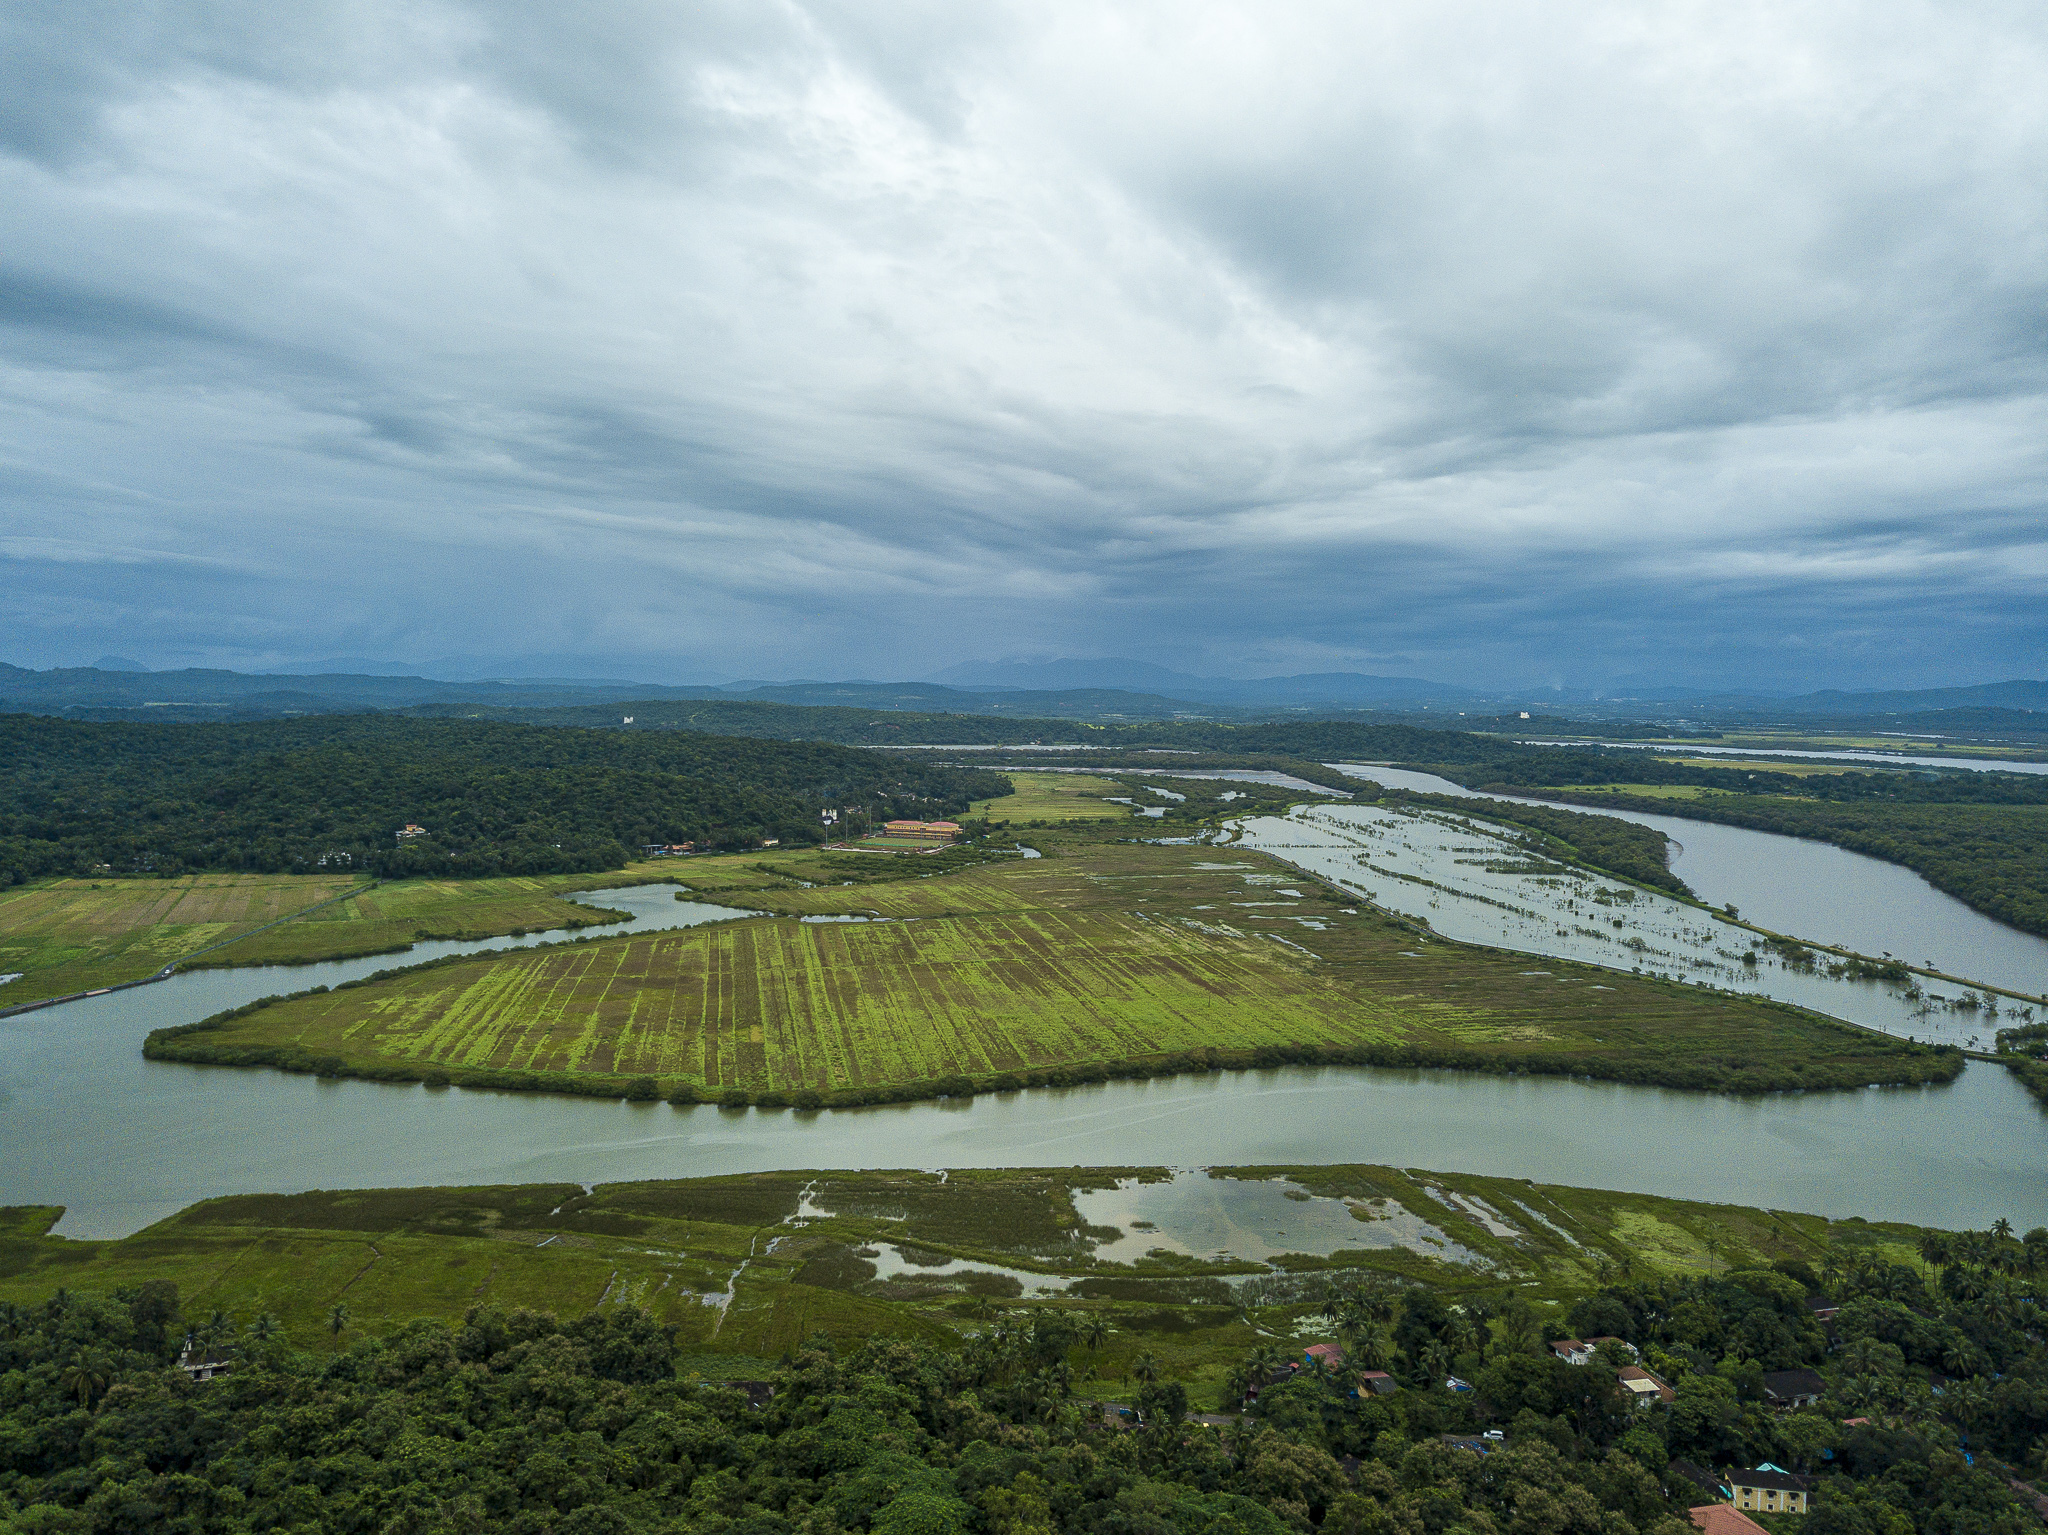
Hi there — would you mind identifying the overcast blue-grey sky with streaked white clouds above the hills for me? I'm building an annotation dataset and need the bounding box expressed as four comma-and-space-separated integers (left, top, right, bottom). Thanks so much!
0, 0, 2048, 686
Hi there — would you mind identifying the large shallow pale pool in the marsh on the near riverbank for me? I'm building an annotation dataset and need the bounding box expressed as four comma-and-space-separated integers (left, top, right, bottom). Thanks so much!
1073, 1171, 1483, 1263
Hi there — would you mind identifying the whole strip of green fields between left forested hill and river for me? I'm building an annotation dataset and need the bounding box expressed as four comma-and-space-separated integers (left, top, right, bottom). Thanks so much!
0, 862, 674, 1007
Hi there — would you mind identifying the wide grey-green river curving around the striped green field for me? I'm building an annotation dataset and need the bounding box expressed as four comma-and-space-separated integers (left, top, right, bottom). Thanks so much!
0, 859, 2048, 1238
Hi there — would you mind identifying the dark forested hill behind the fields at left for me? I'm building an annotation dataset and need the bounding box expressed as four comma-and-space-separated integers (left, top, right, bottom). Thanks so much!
0, 714, 1010, 882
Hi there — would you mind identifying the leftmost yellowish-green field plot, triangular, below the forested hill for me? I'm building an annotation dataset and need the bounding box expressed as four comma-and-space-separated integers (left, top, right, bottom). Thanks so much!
0, 874, 356, 1007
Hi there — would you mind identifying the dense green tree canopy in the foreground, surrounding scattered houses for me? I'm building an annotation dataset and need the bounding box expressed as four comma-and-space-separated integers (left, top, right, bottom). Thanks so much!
0, 1226, 2048, 1535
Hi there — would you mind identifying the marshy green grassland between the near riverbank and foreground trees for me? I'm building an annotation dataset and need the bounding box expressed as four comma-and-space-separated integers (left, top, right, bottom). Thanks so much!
0, 1170, 1919, 1400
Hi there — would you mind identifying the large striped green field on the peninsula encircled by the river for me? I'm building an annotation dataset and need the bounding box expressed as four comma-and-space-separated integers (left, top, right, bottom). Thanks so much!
147, 831, 1960, 1107
